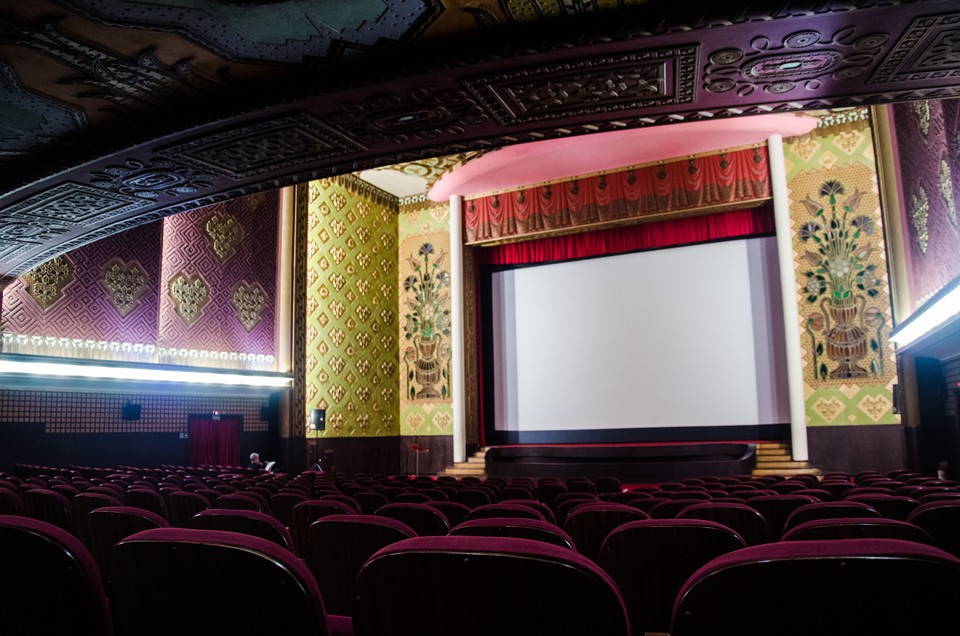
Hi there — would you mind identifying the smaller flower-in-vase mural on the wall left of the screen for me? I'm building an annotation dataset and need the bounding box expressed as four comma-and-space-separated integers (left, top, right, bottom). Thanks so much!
403, 243, 450, 400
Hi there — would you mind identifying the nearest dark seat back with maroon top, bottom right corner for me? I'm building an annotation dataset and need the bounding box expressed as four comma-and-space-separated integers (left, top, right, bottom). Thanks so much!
670, 539, 960, 636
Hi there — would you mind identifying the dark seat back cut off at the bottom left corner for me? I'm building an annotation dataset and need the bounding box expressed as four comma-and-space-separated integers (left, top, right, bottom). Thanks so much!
0, 515, 113, 636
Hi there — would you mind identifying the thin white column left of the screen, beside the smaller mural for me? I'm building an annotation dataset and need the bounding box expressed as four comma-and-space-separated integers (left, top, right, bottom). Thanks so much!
450, 195, 467, 462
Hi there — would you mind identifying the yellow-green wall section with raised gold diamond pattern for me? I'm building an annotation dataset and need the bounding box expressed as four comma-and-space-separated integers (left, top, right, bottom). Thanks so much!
306, 177, 399, 437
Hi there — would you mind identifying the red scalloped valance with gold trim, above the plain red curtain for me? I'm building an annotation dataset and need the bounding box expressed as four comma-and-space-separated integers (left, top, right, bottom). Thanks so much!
463, 147, 771, 244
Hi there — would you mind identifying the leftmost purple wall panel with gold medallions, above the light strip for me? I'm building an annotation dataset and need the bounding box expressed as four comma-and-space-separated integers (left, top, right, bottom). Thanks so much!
0, 223, 163, 362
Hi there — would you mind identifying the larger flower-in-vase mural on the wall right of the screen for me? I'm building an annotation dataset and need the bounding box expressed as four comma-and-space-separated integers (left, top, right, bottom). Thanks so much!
800, 180, 885, 380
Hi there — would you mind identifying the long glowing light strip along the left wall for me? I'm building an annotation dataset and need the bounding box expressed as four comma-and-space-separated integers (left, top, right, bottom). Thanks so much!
0, 358, 291, 388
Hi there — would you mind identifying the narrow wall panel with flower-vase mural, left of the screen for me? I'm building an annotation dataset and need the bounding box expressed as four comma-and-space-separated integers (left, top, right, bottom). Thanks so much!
398, 201, 453, 435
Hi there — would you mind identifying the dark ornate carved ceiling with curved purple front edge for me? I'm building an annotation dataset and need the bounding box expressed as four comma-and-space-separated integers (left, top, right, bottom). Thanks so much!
0, 0, 960, 280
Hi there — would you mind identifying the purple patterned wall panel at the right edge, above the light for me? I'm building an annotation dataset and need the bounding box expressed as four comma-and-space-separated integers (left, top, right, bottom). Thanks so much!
892, 99, 960, 309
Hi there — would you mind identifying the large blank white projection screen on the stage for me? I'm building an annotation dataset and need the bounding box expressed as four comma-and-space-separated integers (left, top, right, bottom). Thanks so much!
484, 237, 789, 442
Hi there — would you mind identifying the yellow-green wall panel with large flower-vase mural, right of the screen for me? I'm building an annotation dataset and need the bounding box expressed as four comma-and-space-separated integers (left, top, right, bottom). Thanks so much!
784, 110, 899, 426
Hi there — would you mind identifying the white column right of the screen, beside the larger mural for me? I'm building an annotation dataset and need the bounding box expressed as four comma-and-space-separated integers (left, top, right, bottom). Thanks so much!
767, 135, 809, 461
